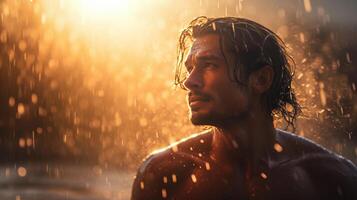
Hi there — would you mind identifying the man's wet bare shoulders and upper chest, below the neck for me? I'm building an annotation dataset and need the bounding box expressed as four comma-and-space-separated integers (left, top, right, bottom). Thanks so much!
132, 130, 357, 200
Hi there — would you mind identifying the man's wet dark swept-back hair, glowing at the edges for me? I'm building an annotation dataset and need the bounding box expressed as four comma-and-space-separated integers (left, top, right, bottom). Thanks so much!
175, 16, 301, 130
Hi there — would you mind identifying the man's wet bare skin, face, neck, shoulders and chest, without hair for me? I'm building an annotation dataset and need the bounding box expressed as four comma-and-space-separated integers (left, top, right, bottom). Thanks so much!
132, 34, 357, 200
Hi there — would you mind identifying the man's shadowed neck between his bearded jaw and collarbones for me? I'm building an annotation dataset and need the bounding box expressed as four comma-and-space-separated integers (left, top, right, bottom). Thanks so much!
211, 109, 275, 167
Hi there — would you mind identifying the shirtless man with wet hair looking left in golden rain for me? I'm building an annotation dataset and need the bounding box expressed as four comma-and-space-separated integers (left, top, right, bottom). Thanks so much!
132, 17, 357, 200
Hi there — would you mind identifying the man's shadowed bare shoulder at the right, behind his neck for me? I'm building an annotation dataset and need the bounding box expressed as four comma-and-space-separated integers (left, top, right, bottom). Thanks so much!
271, 129, 357, 199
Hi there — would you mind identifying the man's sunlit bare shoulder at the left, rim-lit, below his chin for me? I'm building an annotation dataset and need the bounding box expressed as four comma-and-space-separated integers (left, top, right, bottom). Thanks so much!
132, 131, 212, 200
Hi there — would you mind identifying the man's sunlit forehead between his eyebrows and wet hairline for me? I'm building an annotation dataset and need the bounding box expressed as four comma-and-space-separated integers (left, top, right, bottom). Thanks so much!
187, 34, 221, 60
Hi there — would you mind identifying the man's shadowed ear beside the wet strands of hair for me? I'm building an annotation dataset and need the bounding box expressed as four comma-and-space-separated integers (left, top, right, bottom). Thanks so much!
249, 65, 274, 94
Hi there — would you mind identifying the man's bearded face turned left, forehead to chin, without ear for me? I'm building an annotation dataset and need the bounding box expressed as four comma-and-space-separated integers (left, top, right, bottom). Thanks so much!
184, 34, 250, 126
